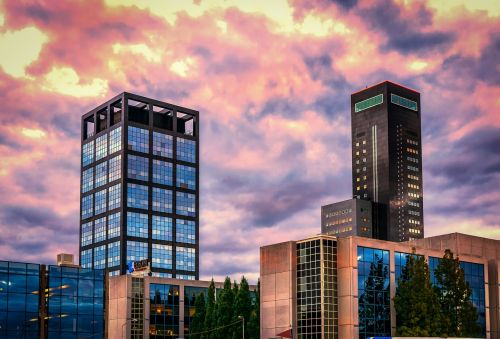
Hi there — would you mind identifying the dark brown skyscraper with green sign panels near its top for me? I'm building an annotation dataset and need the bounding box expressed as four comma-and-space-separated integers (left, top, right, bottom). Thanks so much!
351, 81, 424, 241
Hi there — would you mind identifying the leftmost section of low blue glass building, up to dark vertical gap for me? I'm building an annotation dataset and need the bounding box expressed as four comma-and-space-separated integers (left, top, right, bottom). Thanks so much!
0, 261, 40, 339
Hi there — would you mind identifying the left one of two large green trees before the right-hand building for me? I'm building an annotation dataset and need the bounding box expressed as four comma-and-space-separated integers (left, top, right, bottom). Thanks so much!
394, 254, 441, 337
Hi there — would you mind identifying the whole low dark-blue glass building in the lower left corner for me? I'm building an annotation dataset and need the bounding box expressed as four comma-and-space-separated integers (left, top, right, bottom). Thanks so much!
0, 261, 105, 339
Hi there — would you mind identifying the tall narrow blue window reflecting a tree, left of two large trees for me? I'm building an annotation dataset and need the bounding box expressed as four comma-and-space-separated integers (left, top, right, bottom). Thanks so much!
358, 246, 391, 339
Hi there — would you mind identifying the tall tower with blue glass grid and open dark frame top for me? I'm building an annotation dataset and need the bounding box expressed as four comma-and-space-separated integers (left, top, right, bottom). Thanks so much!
80, 93, 199, 279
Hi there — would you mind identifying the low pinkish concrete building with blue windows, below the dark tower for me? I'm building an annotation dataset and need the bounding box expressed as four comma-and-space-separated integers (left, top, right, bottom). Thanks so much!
261, 234, 500, 339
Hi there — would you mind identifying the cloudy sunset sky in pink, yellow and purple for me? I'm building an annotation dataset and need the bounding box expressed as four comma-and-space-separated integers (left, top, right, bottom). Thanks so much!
0, 0, 500, 282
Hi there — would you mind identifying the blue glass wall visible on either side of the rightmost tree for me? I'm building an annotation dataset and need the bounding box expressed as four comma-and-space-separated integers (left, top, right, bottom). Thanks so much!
429, 257, 486, 335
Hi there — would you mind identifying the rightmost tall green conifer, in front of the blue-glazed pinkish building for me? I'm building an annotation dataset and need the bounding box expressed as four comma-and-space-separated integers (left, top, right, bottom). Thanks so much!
434, 249, 480, 337
